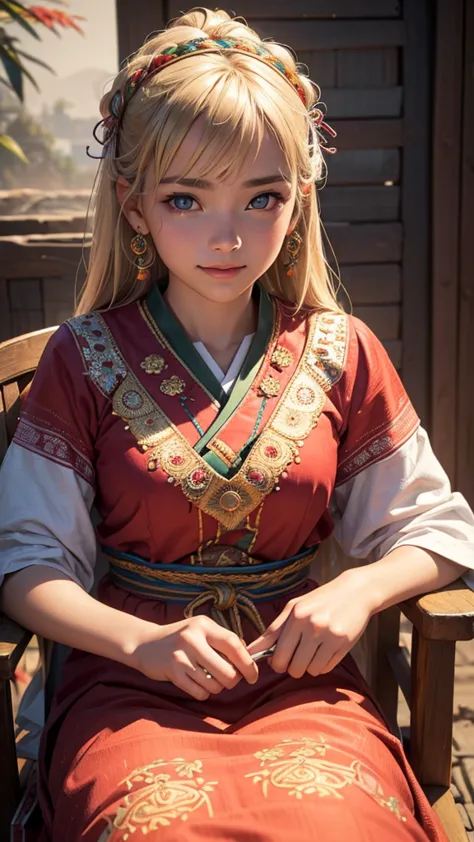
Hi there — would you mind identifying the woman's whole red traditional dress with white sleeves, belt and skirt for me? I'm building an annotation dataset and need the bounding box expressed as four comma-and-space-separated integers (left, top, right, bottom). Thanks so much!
0, 286, 474, 842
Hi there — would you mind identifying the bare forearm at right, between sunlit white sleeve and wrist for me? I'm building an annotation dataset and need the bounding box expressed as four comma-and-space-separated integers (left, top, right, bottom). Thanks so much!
347, 545, 465, 614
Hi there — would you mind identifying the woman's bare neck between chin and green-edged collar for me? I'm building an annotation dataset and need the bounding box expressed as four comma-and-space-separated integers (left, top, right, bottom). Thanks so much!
163, 279, 258, 356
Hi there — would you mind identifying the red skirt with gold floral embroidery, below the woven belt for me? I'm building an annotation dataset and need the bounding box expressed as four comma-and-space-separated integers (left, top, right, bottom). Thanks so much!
40, 580, 447, 842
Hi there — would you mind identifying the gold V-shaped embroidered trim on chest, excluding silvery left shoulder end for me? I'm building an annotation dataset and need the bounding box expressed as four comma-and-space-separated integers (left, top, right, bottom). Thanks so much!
104, 313, 347, 530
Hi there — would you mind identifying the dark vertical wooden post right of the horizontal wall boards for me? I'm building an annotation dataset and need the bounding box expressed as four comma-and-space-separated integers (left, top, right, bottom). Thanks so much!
402, 0, 432, 429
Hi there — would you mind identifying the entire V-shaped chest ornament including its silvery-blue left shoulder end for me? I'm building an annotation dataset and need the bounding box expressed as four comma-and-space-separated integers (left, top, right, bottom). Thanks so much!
69, 313, 347, 530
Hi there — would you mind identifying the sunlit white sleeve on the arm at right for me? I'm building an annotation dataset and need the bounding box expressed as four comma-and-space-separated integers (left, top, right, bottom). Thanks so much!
331, 428, 474, 589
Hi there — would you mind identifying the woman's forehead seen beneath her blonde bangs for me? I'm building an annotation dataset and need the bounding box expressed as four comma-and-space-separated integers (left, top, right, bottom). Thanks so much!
163, 118, 290, 184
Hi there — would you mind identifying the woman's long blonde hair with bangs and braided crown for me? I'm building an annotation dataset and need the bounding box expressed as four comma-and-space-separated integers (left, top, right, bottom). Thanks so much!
76, 8, 341, 314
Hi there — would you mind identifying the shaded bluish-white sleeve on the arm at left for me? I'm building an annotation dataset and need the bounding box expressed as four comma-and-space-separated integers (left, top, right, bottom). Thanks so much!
0, 443, 97, 591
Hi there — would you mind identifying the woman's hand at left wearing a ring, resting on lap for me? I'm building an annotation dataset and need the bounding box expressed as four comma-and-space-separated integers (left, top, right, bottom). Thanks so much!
134, 615, 258, 701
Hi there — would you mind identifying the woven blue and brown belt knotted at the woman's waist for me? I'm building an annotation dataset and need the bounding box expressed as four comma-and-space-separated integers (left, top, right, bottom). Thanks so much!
102, 546, 318, 637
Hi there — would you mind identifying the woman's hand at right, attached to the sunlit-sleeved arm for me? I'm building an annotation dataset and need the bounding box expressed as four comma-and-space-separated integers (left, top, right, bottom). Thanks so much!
248, 568, 373, 678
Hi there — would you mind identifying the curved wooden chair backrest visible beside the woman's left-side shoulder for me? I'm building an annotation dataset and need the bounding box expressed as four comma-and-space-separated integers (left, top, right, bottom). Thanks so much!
0, 327, 57, 463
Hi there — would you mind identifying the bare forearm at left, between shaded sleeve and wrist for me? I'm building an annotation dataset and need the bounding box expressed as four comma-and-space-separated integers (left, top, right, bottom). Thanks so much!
0, 565, 156, 667
